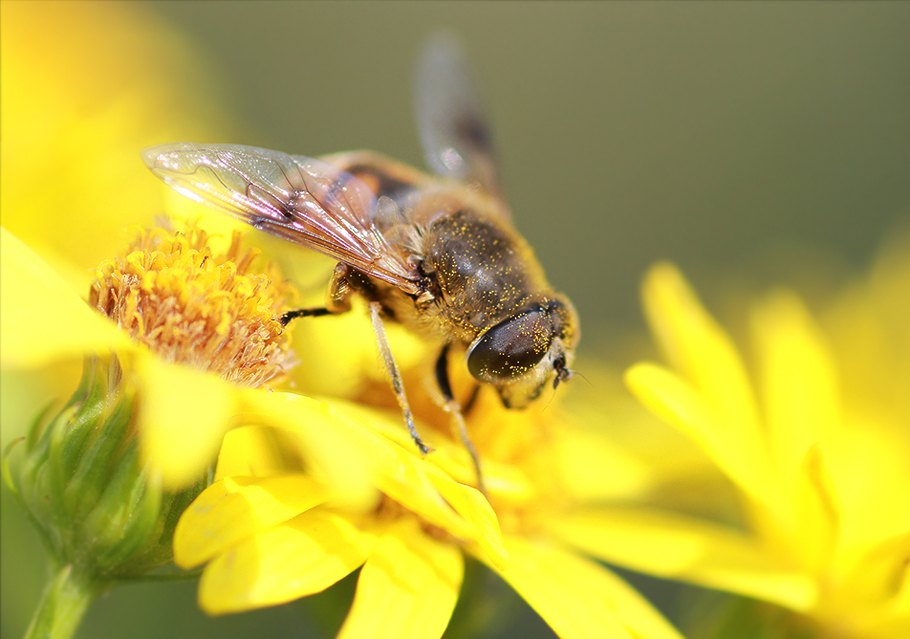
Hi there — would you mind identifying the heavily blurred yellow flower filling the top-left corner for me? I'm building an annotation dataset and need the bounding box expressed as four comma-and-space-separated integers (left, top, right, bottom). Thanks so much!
0, 2, 235, 292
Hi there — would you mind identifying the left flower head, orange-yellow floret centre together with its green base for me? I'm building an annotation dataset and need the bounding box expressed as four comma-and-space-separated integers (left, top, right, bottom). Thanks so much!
4, 224, 294, 590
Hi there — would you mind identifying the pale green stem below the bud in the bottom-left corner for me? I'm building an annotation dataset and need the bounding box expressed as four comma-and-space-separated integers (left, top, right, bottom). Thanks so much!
24, 564, 102, 639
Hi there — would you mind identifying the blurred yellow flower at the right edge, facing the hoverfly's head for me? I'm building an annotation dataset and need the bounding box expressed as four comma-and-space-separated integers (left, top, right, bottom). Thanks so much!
566, 243, 910, 639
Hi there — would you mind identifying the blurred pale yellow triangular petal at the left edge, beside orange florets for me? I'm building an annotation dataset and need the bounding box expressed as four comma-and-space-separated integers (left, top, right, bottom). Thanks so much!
0, 228, 132, 367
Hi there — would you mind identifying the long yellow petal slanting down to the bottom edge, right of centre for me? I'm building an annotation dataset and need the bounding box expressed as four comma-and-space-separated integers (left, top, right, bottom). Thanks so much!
480, 536, 679, 639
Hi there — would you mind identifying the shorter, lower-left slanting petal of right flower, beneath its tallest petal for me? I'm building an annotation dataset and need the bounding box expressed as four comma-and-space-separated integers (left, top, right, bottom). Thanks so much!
626, 364, 779, 507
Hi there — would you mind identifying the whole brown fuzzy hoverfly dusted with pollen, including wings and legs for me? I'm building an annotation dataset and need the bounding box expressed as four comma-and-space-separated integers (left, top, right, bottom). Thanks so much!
143, 38, 579, 488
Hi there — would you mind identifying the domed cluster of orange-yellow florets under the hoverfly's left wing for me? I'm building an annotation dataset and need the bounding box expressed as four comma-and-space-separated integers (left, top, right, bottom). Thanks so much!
89, 223, 296, 387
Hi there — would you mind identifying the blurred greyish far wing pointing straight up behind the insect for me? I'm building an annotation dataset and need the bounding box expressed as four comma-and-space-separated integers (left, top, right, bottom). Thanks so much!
414, 33, 502, 209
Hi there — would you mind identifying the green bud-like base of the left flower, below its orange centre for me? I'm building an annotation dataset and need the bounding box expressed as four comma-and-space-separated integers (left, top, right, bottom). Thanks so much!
6, 356, 207, 582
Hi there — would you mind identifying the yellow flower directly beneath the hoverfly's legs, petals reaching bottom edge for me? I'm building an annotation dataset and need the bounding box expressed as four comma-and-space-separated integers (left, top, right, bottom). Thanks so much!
174, 286, 678, 638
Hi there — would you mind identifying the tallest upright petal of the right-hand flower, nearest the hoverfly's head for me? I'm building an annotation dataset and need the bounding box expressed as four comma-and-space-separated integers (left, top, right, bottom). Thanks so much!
643, 264, 770, 495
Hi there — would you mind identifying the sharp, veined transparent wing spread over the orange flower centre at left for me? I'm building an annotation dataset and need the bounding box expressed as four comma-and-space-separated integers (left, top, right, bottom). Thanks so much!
142, 142, 420, 293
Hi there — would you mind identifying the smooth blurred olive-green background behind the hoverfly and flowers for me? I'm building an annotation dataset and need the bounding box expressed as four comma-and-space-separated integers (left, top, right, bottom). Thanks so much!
0, 2, 910, 639
